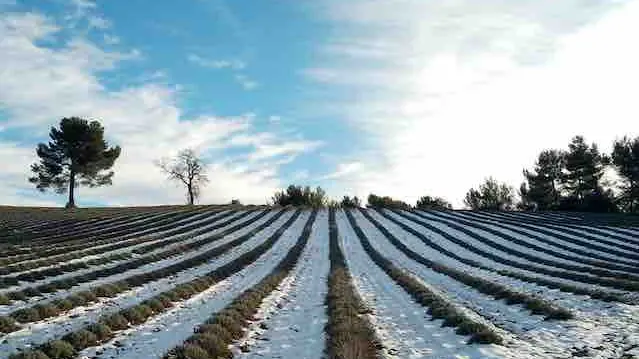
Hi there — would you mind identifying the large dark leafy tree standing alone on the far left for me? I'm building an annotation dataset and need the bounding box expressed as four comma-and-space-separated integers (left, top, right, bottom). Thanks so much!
29, 117, 121, 208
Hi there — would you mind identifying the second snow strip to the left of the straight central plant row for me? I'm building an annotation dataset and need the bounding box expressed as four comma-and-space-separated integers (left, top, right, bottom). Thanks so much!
80, 211, 310, 359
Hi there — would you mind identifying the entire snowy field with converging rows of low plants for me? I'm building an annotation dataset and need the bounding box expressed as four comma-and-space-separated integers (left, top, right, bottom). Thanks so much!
0, 206, 639, 359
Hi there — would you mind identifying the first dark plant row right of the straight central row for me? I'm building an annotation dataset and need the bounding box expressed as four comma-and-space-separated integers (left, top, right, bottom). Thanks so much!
346, 210, 503, 344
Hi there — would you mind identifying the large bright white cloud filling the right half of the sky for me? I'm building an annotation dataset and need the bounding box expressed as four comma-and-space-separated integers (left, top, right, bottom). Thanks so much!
305, 0, 639, 205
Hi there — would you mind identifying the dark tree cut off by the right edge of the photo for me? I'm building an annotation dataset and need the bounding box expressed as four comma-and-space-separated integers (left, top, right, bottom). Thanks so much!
611, 137, 639, 212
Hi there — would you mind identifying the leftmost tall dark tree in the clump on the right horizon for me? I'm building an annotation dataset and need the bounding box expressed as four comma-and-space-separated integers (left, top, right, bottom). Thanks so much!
519, 150, 564, 210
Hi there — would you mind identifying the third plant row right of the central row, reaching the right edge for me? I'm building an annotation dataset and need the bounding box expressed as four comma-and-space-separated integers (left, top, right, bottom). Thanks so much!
379, 212, 635, 304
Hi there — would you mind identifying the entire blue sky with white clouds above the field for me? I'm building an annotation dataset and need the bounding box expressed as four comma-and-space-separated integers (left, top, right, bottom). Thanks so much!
0, 0, 639, 208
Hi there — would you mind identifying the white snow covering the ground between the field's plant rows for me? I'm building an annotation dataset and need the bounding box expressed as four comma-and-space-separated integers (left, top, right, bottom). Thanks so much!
0, 208, 639, 359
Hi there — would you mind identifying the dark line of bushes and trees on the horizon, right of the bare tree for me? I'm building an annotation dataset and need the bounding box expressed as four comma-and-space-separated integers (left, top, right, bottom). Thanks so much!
272, 136, 639, 213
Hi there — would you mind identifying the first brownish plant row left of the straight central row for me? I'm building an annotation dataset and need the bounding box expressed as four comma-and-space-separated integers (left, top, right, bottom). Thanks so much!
163, 210, 317, 359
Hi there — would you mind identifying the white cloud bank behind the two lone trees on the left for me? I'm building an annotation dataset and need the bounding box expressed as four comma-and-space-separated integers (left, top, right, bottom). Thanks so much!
0, 11, 317, 205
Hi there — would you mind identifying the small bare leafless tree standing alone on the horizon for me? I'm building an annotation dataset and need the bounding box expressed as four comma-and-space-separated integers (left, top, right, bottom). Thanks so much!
157, 149, 209, 205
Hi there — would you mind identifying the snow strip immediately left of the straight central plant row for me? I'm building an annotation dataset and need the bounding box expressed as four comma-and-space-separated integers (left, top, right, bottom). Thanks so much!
235, 210, 330, 359
